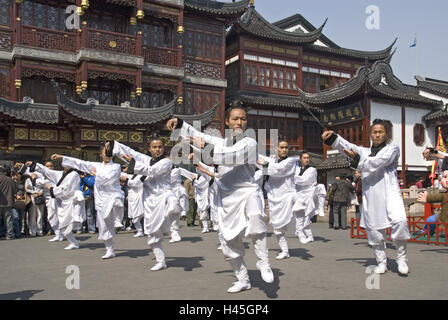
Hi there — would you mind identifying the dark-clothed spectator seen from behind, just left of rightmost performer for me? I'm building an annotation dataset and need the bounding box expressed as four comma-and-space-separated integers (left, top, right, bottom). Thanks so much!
333, 176, 355, 230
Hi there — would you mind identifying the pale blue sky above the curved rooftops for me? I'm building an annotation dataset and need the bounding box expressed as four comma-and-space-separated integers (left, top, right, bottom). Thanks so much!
245, 0, 448, 85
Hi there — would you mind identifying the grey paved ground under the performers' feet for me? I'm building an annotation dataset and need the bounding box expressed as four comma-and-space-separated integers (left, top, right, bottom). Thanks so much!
0, 223, 448, 300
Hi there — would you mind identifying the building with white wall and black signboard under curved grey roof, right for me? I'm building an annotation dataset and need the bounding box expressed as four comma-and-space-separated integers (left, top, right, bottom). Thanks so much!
299, 61, 443, 183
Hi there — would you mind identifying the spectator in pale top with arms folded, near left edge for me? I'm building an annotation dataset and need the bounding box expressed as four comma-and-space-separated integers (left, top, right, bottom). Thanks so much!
25, 172, 45, 237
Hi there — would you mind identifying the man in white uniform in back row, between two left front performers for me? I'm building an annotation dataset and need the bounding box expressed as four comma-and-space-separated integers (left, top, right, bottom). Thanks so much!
120, 173, 146, 238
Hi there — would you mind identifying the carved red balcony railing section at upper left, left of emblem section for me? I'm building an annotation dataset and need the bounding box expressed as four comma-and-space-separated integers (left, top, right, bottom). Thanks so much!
22, 25, 77, 52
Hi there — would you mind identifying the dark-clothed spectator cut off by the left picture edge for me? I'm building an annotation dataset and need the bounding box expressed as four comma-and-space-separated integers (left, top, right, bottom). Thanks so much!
0, 166, 15, 240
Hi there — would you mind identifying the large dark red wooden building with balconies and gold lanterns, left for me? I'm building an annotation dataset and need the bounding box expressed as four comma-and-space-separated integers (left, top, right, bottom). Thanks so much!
0, 0, 249, 160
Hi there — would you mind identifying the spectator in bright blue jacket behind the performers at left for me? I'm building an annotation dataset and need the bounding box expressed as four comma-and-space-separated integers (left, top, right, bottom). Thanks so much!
76, 172, 96, 234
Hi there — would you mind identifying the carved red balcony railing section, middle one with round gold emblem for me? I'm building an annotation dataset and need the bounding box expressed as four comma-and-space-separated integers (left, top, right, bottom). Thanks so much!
83, 28, 138, 55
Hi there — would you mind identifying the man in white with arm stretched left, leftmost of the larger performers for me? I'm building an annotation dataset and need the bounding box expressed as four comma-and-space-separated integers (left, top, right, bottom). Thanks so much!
51, 144, 124, 259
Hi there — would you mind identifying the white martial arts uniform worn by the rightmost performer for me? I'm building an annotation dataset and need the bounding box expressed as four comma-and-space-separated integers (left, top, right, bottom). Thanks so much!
332, 136, 410, 270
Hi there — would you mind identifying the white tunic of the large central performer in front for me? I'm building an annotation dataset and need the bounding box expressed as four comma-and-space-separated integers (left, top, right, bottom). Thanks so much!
180, 122, 264, 241
